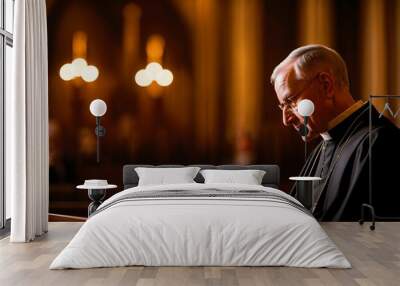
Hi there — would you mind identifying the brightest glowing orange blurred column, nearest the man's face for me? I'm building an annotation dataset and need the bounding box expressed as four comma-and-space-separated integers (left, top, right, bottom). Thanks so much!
227, 0, 268, 164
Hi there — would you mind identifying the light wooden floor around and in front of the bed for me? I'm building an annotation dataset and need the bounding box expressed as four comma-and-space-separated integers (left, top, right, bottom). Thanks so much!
0, 222, 400, 286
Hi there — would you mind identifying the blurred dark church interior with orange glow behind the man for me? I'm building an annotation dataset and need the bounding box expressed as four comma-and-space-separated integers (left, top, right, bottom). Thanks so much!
47, 0, 400, 216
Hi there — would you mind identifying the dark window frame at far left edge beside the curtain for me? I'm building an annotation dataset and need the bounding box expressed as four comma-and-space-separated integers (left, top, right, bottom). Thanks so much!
0, 0, 15, 230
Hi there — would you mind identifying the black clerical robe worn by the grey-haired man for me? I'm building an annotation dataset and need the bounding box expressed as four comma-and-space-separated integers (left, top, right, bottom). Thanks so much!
300, 102, 400, 221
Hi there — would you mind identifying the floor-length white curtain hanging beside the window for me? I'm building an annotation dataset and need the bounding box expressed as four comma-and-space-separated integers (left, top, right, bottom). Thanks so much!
6, 0, 49, 242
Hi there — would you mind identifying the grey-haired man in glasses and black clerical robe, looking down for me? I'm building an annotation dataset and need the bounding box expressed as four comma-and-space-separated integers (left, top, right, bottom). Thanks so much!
271, 45, 400, 221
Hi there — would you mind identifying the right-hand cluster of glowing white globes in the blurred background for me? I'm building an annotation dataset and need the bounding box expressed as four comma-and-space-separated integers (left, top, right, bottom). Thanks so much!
135, 62, 174, 87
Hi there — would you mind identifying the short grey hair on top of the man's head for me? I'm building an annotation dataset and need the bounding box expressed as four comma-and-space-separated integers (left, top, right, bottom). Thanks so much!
271, 45, 349, 89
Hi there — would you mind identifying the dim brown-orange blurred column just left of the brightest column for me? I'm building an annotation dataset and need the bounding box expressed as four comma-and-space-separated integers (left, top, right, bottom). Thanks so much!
192, 0, 221, 163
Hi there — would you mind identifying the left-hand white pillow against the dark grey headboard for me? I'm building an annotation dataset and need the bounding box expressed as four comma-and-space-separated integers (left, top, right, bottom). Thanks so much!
135, 167, 200, 186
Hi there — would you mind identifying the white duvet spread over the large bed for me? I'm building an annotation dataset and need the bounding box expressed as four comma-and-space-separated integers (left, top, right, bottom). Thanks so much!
50, 184, 351, 269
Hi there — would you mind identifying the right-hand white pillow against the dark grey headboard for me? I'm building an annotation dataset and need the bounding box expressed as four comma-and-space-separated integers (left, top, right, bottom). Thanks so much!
200, 169, 265, 185
